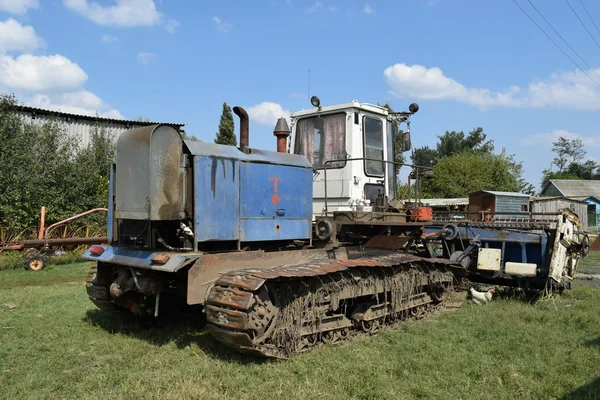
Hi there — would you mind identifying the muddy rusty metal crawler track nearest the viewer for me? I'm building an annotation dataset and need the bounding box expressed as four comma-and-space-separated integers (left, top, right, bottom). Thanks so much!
206, 253, 453, 358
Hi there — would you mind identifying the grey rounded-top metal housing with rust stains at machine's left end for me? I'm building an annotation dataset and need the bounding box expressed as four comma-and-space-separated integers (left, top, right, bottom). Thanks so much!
115, 125, 185, 220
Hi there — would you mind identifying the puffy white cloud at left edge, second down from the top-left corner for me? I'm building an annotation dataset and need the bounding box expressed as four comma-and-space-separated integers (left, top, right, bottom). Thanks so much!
0, 54, 87, 92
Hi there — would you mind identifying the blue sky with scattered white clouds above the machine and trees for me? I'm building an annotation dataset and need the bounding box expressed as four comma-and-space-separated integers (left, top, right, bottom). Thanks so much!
0, 0, 600, 190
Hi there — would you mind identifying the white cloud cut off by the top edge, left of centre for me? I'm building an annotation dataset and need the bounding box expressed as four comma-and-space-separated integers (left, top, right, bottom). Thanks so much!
63, 0, 162, 27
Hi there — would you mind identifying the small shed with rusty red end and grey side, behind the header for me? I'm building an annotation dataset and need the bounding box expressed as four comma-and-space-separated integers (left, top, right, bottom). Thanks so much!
469, 190, 530, 220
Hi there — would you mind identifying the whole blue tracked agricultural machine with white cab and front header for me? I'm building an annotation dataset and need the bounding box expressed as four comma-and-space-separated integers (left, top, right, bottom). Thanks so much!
84, 97, 585, 357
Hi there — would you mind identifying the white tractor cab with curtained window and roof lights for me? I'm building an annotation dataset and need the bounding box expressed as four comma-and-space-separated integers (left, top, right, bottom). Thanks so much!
288, 96, 418, 220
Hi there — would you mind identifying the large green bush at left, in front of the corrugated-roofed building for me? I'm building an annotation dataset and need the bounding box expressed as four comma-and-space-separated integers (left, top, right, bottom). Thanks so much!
0, 95, 115, 231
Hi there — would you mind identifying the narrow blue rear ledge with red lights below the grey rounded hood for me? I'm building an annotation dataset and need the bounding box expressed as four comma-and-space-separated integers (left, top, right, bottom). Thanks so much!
83, 245, 199, 272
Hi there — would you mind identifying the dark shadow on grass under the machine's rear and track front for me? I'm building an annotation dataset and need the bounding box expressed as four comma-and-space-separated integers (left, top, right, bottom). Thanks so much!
83, 309, 268, 364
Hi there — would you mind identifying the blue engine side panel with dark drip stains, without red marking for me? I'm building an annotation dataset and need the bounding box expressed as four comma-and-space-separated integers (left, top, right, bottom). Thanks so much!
194, 156, 240, 242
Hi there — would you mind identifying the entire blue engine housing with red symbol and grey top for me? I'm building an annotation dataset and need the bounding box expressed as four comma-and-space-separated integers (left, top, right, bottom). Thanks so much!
186, 142, 312, 242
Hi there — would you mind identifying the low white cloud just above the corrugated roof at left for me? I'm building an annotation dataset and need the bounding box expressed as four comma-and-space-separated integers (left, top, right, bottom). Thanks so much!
30, 90, 125, 119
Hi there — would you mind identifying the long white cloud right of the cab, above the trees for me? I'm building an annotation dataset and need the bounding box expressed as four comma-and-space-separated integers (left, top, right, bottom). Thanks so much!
383, 64, 600, 110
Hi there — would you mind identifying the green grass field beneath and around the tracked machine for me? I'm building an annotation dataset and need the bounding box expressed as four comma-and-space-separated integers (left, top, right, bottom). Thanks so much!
0, 256, 600, 400
